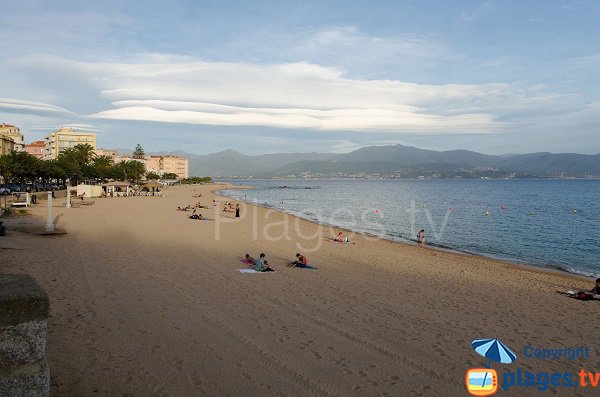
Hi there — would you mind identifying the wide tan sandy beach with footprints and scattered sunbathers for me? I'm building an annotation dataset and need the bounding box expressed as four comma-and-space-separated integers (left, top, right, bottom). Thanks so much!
0, 185, 600, 396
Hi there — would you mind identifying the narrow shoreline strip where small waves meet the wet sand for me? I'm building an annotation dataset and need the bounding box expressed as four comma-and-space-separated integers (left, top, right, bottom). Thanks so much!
216, 182, 597, 282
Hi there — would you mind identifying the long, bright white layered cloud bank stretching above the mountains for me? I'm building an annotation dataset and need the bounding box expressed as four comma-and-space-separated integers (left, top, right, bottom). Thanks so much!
8, 54, 592, 134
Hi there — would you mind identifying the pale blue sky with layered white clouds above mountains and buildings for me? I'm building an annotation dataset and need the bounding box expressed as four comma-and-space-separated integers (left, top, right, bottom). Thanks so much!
0, 0, 600, 154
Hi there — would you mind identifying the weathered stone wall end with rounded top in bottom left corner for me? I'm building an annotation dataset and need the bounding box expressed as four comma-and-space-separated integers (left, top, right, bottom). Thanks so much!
0, 274, 50, 397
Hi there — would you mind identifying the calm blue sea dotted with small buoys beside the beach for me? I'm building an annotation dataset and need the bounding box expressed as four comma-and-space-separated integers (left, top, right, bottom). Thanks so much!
222, 179, 600, 277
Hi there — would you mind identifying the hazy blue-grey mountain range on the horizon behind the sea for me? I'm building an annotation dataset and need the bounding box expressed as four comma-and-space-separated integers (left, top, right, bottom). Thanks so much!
148, 145, 600, 178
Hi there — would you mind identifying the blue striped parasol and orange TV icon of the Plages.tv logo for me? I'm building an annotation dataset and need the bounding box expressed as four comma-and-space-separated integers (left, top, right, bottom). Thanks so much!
465, 338, 517, 396
